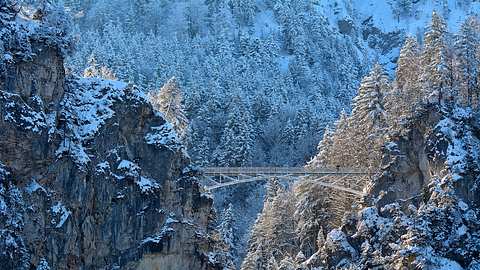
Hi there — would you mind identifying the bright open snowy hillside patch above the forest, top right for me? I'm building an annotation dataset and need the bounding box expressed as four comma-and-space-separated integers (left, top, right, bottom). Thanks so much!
316, 0, 480, 71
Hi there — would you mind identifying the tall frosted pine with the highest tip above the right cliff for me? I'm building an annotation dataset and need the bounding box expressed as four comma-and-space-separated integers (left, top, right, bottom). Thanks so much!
422, 12, 452, 104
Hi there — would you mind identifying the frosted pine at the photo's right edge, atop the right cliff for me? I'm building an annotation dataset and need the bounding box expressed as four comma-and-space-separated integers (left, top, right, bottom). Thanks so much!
455, 16, 480, 106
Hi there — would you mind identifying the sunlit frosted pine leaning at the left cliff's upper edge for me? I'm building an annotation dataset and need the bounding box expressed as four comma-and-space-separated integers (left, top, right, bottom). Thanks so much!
150, 77, 189, 138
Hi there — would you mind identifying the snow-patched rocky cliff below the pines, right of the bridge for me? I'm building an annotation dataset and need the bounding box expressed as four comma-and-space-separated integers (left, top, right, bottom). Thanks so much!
304, 105, 480, 269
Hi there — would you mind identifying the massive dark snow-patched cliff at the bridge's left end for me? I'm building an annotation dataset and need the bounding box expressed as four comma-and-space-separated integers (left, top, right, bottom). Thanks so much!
0, 6, 225, 270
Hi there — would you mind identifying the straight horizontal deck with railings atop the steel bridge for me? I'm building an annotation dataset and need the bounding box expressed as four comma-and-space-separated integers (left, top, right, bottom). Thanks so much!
203, 167, 368, 176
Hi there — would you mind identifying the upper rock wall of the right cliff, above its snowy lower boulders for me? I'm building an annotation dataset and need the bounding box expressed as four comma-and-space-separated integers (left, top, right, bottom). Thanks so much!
370, 104, 480, 207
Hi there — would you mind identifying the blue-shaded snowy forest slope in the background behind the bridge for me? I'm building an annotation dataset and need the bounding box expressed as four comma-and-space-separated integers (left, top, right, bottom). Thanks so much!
64, 0, 479, 165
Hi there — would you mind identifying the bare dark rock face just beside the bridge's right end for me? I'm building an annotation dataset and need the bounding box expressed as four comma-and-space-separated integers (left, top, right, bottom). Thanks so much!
371, 106, 444, 206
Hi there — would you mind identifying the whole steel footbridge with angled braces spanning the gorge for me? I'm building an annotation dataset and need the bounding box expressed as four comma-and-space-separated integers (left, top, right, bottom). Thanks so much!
203, 167, 370, 196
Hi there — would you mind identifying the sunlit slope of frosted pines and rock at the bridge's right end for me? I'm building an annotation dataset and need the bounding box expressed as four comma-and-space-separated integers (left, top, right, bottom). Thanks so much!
242, 13, 480, 269
